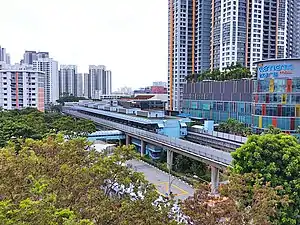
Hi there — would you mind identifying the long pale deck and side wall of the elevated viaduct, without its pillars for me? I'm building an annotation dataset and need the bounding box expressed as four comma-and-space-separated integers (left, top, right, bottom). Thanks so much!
63, 110, 232, 166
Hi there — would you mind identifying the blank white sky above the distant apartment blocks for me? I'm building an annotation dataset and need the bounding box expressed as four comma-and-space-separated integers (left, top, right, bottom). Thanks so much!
0, 0, 168, 90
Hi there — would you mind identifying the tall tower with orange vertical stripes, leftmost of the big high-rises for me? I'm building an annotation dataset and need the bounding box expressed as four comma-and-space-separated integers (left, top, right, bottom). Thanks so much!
168, 0, 212, 111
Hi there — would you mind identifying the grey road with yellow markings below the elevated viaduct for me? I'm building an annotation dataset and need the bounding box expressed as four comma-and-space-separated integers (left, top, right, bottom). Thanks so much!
128, 160, 194, 200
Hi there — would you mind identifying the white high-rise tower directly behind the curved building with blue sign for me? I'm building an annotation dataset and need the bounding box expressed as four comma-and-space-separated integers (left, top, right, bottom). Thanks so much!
246, 0, 299, 71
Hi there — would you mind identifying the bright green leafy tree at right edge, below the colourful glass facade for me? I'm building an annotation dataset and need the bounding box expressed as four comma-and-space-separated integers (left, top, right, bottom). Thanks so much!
232, 133, 300, 225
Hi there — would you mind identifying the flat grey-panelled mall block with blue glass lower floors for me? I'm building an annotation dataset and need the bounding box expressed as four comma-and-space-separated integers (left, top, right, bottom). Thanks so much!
183, 79, 253, 126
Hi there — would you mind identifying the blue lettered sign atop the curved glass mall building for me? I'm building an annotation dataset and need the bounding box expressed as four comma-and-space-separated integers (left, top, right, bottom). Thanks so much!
257, 64, 295, 79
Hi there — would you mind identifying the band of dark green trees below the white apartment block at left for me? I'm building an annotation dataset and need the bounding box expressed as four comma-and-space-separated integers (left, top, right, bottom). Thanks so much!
0, 108, 96, 147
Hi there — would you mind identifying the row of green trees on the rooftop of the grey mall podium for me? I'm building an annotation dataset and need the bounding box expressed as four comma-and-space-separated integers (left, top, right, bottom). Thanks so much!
186, 63, 252, 82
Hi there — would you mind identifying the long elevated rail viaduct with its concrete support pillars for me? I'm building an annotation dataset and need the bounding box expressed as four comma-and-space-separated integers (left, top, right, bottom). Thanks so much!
63, 107, 232, 193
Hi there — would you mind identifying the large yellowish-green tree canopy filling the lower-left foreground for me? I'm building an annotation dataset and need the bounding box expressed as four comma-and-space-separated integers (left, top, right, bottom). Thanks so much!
0, 135, 176, 225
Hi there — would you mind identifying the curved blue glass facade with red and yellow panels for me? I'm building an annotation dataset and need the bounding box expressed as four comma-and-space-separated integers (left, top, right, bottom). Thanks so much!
252, 78, 300, 133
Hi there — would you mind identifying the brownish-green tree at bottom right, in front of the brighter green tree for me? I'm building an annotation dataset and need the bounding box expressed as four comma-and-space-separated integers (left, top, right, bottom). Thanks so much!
182, 174, 289, 225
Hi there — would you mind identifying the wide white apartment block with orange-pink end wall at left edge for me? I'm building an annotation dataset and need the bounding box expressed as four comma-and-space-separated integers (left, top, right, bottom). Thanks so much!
0, 65, 45, 111
